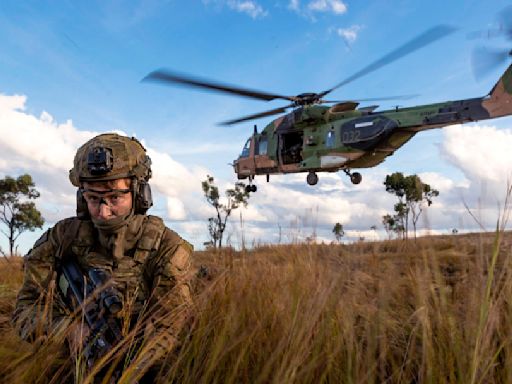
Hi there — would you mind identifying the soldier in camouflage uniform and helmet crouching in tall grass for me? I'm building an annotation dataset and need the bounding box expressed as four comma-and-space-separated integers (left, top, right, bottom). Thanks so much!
13, 134, 193, 382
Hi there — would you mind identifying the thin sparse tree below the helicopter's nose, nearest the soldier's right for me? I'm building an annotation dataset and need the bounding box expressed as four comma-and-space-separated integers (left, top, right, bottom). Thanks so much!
201, 175, 249, 248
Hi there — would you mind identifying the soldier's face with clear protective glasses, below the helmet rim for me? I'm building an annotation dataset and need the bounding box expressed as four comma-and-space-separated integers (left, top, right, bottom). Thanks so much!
83, 179, 132, 220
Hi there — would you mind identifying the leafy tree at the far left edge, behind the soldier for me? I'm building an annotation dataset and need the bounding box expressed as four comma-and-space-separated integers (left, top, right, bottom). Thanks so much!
0, 174, 44, 255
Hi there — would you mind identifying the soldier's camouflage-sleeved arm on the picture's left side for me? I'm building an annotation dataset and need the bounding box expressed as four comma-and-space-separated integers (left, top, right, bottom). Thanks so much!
12, 222, 70, 341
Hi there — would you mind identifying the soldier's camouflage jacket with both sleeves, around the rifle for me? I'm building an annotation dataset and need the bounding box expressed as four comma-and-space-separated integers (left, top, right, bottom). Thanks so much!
13, 215, 194, 362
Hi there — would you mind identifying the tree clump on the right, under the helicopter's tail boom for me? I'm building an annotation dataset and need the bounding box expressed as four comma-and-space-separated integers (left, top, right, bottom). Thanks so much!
384, 172, 439, 238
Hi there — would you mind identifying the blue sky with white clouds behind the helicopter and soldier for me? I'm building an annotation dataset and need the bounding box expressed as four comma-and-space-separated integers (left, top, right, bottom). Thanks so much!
0, 0, 512, 253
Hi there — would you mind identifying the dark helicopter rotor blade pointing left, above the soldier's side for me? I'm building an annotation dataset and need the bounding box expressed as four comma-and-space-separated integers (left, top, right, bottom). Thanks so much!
142, 69, 295, 101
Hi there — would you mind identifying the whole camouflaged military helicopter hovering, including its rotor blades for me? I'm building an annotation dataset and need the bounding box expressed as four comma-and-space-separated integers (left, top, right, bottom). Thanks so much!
143, 20, 512, 192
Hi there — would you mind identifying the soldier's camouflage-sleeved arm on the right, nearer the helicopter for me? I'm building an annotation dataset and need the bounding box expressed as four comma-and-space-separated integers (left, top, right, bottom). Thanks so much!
142, 229, 194, 359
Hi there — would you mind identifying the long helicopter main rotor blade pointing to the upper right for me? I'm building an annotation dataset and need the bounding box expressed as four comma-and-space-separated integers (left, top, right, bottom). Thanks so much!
319, 25, 456, 97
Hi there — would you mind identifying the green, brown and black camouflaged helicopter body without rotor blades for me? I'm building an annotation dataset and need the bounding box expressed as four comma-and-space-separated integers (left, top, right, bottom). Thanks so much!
233, 65, 512, 190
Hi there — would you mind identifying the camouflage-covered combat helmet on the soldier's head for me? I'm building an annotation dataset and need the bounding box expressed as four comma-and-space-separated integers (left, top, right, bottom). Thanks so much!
69, 133, 151, 187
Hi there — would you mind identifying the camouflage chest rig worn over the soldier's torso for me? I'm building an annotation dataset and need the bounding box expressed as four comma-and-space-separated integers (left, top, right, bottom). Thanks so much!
61, 216, 165, 314
